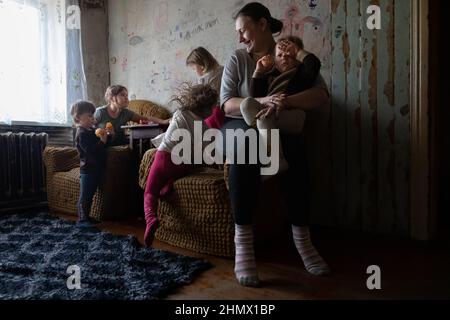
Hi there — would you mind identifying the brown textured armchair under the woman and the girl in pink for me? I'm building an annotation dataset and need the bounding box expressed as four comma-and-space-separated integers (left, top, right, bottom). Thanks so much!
139, 149, 285, 257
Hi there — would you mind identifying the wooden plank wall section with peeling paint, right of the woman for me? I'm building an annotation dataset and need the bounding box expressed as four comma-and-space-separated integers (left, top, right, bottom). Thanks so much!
307, 0, 410, 236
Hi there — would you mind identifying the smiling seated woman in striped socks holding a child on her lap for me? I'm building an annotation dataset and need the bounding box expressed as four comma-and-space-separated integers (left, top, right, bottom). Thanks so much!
220, 2, 330, 286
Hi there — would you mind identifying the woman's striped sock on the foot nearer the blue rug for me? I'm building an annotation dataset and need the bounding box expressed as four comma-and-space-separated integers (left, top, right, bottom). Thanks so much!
234, 224, 259, 287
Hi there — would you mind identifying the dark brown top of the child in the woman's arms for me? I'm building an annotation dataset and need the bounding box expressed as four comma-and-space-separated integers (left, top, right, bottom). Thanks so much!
251, 54, 321, 98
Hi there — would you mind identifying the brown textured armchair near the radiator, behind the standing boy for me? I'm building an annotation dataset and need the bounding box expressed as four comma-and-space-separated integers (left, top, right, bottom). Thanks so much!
43, 100, 171, 221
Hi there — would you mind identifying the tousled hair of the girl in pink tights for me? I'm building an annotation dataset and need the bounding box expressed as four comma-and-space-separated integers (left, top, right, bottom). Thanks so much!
171, 82, 219, 118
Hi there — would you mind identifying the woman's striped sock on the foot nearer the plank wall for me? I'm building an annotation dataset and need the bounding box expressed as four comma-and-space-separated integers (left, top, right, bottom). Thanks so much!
292, 226, 331, 276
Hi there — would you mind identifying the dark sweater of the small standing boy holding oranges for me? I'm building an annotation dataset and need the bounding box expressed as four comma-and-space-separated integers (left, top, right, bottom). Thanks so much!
75, 127, 106, 174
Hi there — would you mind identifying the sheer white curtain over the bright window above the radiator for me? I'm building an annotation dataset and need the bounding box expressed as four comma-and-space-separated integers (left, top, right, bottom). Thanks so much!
0, 0, 86, 125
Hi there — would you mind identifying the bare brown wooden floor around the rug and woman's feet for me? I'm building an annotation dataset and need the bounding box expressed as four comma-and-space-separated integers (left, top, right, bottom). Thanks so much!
55, 212, 450, 300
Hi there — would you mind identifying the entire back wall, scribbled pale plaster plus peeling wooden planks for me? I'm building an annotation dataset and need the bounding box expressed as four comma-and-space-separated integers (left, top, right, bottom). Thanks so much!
109, 0, 410, 235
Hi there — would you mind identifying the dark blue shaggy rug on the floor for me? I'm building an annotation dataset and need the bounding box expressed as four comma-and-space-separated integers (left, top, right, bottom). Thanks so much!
0, 213, 211, 300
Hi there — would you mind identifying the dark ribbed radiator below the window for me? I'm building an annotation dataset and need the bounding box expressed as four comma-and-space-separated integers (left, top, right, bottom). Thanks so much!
0, 132, 48, 203
